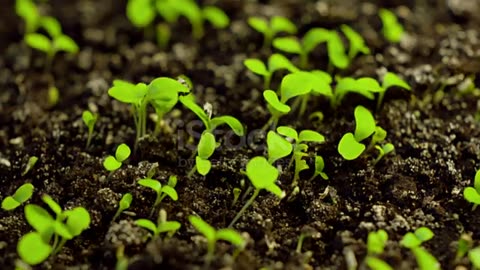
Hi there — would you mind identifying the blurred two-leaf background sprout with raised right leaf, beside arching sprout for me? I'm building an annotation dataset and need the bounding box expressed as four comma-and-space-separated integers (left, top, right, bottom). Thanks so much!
273, 28, 332, 69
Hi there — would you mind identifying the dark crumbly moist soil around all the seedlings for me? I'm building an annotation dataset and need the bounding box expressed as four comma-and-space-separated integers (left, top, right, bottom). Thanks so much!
0, 0, 480, 269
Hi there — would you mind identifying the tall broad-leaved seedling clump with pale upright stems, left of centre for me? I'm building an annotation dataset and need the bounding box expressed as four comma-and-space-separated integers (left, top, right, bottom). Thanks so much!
108, 77, 190, 146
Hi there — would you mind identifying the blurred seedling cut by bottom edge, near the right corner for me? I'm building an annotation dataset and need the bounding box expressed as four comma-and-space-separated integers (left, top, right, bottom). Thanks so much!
400, 227, 440, 270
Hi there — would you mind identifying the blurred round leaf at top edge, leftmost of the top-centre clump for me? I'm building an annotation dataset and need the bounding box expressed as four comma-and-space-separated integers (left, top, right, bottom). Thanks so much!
127, 0, 155, 28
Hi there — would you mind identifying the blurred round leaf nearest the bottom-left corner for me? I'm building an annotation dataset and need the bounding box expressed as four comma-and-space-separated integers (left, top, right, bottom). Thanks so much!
17, 232, 52, 265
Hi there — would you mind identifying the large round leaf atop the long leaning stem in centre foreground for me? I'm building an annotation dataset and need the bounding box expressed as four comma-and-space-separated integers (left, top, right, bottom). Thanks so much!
246, 156, 278, 192
